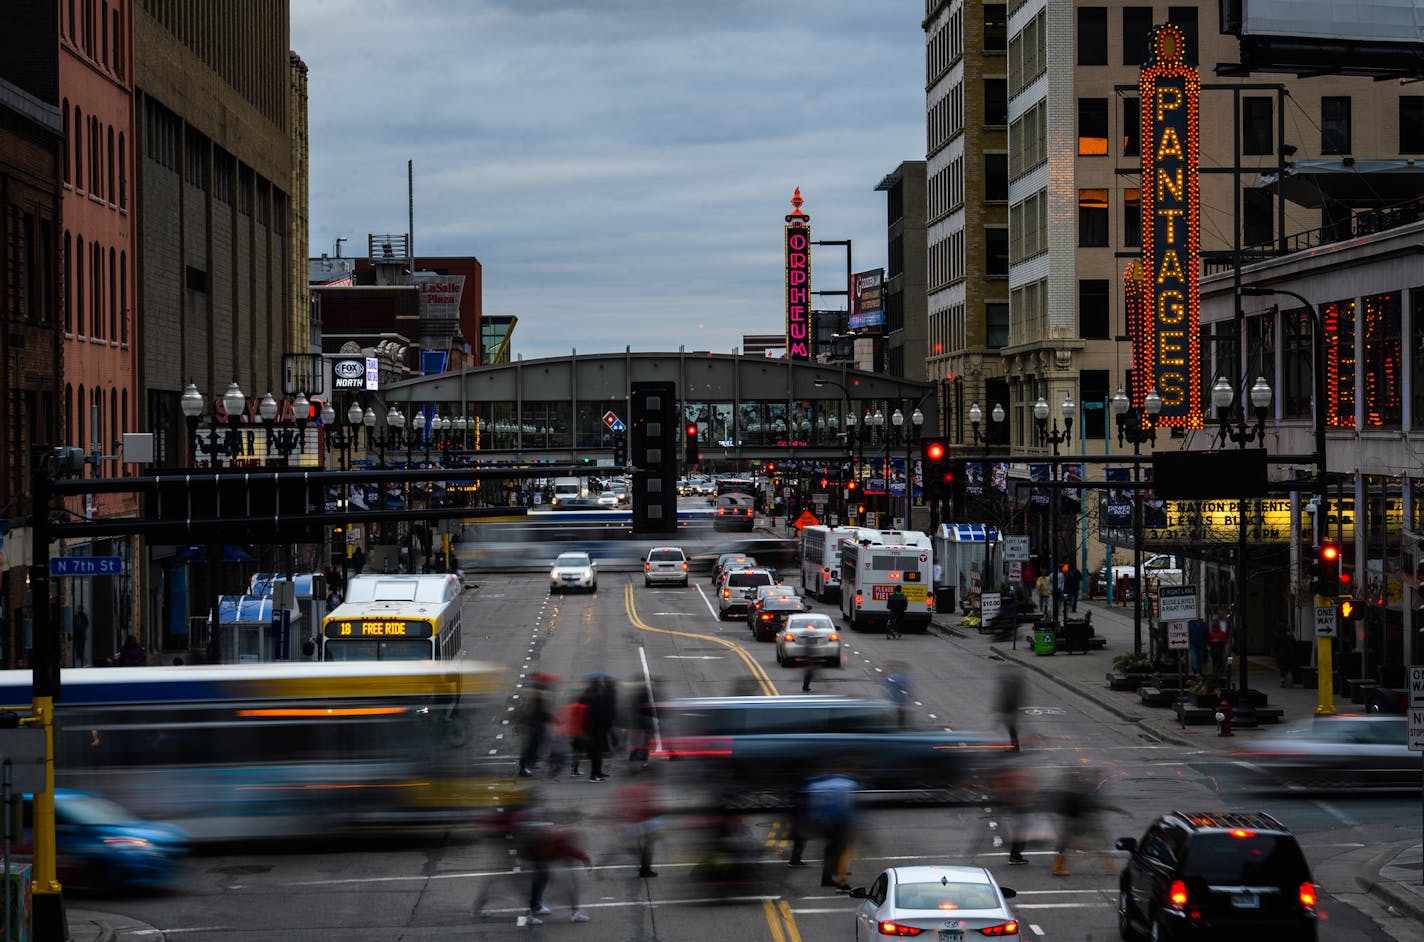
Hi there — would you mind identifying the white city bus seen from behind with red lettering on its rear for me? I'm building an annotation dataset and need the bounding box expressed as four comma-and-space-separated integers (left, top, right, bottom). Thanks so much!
840, 526, 934, 632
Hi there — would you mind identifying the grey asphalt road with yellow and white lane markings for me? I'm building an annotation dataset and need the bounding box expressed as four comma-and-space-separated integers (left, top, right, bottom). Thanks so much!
83, 549, 1418, 942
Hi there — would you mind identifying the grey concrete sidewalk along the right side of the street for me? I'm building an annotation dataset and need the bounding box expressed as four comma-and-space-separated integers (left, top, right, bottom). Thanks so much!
934, 599, 1424, 939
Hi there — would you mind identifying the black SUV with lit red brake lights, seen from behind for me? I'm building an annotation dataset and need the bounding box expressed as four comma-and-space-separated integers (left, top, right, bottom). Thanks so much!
1116, 811, 1316, 941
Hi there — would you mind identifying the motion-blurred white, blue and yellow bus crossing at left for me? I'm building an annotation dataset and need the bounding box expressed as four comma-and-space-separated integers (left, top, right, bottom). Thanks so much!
0, 662, 517, 841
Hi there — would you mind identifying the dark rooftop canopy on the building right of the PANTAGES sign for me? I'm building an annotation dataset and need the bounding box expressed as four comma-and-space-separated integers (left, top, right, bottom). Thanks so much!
1256, 157, 1424, 209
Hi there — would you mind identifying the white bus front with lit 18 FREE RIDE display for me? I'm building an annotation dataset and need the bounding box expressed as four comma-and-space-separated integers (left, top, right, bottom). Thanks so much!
318, 572, 463, 660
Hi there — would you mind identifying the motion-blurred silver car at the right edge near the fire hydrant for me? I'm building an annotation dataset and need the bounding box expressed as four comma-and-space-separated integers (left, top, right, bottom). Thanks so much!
1235, 713, 1420, 790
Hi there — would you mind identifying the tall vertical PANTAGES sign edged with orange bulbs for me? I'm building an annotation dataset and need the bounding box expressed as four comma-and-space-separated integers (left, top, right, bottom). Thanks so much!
1132, 24, 1202, 428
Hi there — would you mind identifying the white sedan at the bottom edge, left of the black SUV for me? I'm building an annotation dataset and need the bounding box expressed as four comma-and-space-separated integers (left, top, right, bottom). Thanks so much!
850, 867, 1020, 942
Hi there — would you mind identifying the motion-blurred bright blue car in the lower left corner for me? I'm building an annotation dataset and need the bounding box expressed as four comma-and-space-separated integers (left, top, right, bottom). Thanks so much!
14, 788, 189, 892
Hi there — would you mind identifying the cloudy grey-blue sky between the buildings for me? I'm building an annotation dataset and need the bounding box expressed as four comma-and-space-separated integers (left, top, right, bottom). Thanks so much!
292, 0, 924, 359
